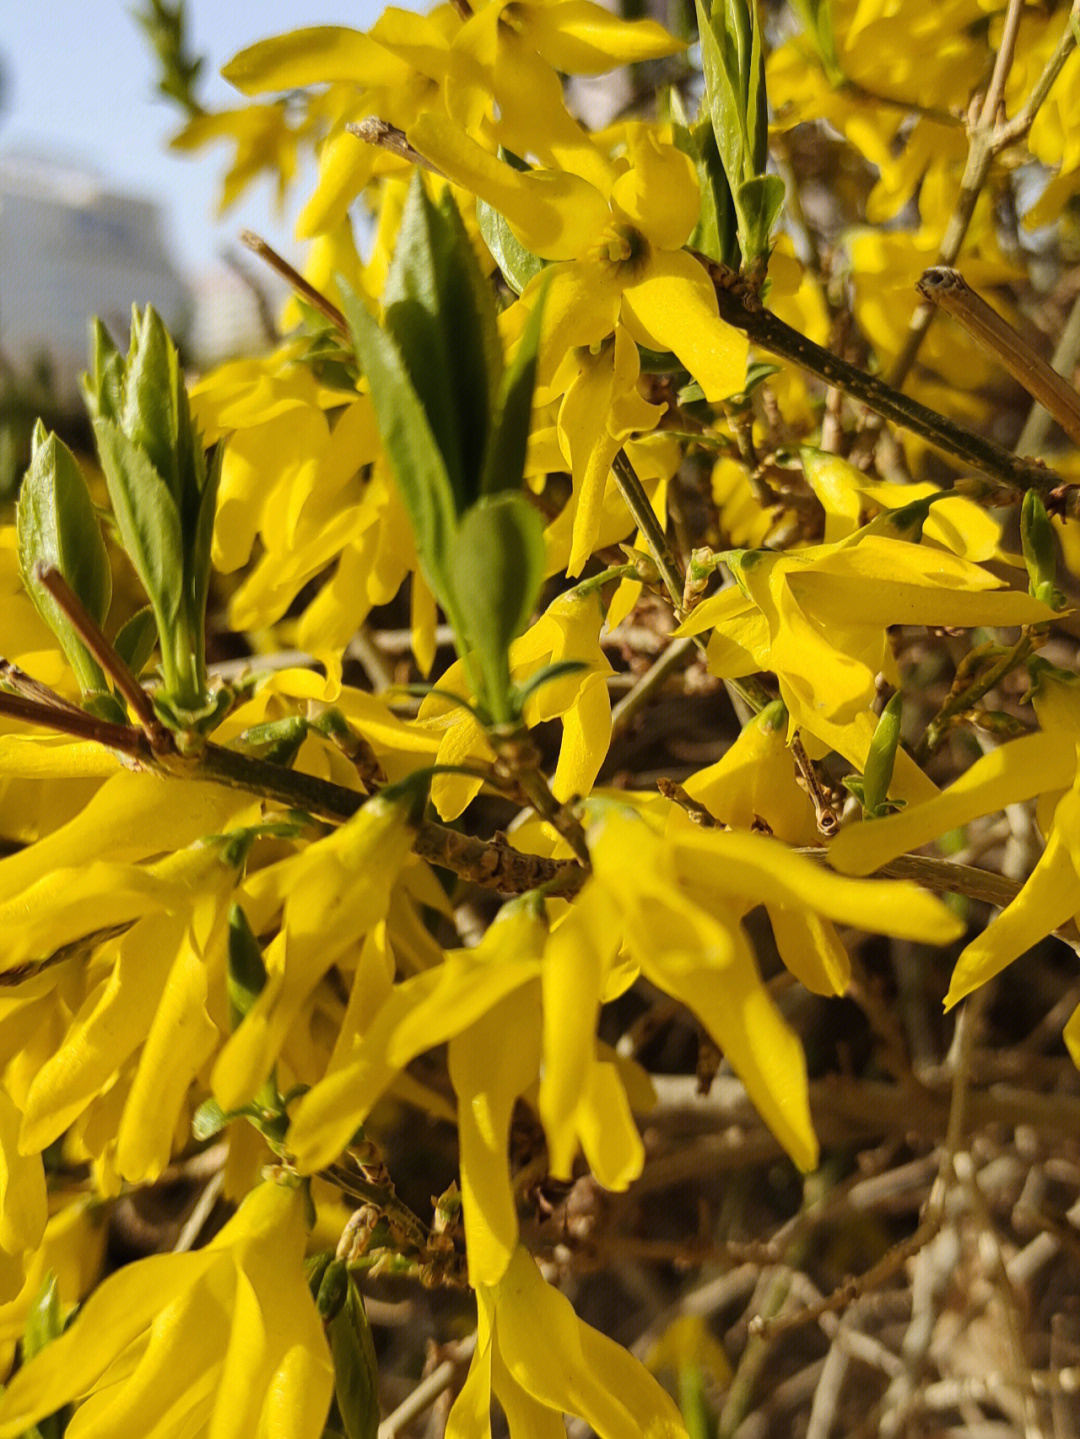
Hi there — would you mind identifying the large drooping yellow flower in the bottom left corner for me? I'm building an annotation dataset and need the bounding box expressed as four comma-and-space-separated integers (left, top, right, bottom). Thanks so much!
0, 1184, 332, 1439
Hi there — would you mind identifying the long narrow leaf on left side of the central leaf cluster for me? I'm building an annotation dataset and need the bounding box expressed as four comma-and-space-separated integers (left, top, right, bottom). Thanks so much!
338, 276, 456, 601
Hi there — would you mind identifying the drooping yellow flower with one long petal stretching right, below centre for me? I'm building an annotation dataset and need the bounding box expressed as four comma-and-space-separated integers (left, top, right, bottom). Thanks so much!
539, 802, 959, 1176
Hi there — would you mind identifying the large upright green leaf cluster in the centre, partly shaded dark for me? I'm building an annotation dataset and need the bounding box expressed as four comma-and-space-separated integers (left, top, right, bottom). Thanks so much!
341, 174, 544, 724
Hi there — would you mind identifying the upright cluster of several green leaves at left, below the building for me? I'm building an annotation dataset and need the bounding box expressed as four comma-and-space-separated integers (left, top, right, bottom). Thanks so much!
83, 305, 220, 728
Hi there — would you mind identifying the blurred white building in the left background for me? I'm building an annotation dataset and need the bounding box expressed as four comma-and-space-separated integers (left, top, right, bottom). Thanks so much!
0, 155, 190, 403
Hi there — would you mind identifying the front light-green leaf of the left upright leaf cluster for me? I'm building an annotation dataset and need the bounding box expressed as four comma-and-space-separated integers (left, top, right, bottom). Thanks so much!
93, 419, 184, 624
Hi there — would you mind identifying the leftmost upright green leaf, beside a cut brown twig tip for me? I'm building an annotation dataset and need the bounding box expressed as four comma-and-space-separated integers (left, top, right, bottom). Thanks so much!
16, 422, 112, 694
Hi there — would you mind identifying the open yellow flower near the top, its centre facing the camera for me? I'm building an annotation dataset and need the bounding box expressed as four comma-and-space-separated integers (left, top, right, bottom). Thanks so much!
408, 111, 748, 400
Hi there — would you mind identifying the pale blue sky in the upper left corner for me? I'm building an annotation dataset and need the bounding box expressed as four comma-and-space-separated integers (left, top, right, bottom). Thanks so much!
0, 0, 408, 273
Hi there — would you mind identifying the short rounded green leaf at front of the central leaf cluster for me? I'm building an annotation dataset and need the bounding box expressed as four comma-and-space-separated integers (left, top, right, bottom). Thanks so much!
449, 491, 545, 722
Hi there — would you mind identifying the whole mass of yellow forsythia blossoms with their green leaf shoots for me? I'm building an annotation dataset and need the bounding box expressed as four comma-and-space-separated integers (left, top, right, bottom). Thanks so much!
0, 0, 1080, 1439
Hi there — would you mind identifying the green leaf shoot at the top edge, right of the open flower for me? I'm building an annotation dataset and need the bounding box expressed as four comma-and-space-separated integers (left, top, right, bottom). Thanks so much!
696, 0, 784, 275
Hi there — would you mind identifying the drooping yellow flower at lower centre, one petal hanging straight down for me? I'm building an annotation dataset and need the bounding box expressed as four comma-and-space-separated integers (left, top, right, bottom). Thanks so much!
286, 896, 649, 1285
